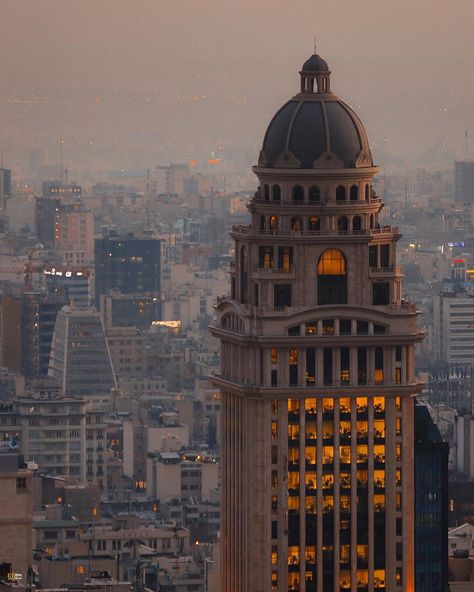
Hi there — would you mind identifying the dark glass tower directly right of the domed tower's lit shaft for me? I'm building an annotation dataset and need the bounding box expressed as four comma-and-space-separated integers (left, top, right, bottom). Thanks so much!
415, 404, 449, 592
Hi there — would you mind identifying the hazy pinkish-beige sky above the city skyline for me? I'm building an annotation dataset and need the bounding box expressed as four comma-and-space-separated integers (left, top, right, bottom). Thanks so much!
0, 0, 474, 173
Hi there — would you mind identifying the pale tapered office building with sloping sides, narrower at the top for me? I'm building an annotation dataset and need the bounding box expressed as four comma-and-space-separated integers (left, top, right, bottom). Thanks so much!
48, 306, 117, 398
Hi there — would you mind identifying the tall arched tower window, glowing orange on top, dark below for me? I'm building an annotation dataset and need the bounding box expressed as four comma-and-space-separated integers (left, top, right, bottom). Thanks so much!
317, 249, 347, 305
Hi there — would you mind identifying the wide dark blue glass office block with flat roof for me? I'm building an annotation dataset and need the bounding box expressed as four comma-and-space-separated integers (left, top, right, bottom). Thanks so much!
95, 234, 161, 308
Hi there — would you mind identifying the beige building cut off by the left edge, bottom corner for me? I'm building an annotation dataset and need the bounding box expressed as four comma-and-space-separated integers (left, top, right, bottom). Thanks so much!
0, 448, 33, 587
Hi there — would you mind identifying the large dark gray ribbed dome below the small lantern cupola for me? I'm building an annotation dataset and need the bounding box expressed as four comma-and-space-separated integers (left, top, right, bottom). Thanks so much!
259, 97, 373, 169
